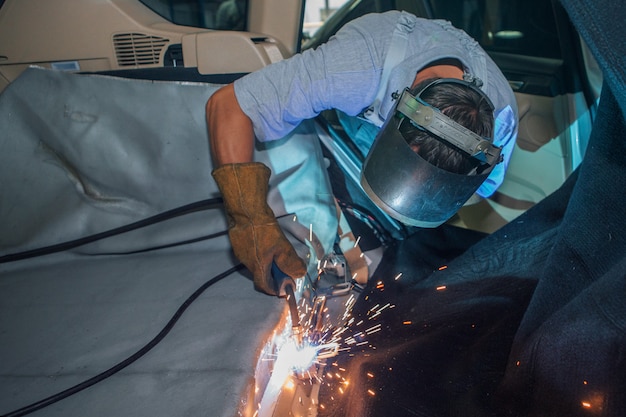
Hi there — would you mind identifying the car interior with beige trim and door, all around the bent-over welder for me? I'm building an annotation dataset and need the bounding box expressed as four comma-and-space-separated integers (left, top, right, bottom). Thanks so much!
0, 0, 601, 237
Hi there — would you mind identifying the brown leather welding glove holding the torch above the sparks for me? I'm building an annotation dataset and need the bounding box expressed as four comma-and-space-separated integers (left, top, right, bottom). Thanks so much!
212, 162, 306, 295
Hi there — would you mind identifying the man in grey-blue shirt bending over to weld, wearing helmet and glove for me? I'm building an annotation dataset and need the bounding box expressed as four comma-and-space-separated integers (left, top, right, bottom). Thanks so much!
206, 11, 517, 294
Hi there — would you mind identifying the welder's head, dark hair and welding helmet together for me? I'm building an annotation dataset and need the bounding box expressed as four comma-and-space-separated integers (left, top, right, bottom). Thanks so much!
361, 78, 501, 227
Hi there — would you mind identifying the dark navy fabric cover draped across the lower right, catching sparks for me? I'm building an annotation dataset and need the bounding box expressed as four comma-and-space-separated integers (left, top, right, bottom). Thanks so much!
321, 0, 626, 417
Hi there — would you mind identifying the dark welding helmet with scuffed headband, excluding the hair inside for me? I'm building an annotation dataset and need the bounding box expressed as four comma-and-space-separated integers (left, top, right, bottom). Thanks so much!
361, 78, 502, 227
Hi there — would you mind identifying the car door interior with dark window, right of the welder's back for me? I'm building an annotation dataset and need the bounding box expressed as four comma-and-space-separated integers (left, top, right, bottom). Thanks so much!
304, 0, 599, 233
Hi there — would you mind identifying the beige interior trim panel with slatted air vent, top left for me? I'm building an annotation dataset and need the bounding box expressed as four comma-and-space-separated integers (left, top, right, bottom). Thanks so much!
0, 0, 294, 91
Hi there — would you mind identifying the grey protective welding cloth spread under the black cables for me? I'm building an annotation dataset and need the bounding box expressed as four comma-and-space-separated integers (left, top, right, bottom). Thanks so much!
0, 68, 336, 416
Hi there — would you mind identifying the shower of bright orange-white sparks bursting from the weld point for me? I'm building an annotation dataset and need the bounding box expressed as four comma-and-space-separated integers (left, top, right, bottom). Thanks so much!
252, 260, 458, 417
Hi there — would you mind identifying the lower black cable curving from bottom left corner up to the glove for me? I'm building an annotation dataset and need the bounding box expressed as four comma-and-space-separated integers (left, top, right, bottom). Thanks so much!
1, 264, 243, 417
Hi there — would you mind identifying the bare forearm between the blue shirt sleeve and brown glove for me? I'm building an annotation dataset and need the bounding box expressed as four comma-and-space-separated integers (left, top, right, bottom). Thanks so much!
206, 84, 254, 167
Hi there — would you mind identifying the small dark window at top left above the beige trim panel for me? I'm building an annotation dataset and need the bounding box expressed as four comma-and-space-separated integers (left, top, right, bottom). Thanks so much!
140, 0, 248, 30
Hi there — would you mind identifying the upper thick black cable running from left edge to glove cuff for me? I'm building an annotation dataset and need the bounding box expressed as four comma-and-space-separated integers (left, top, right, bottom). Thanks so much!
0, 197, 223, 264
